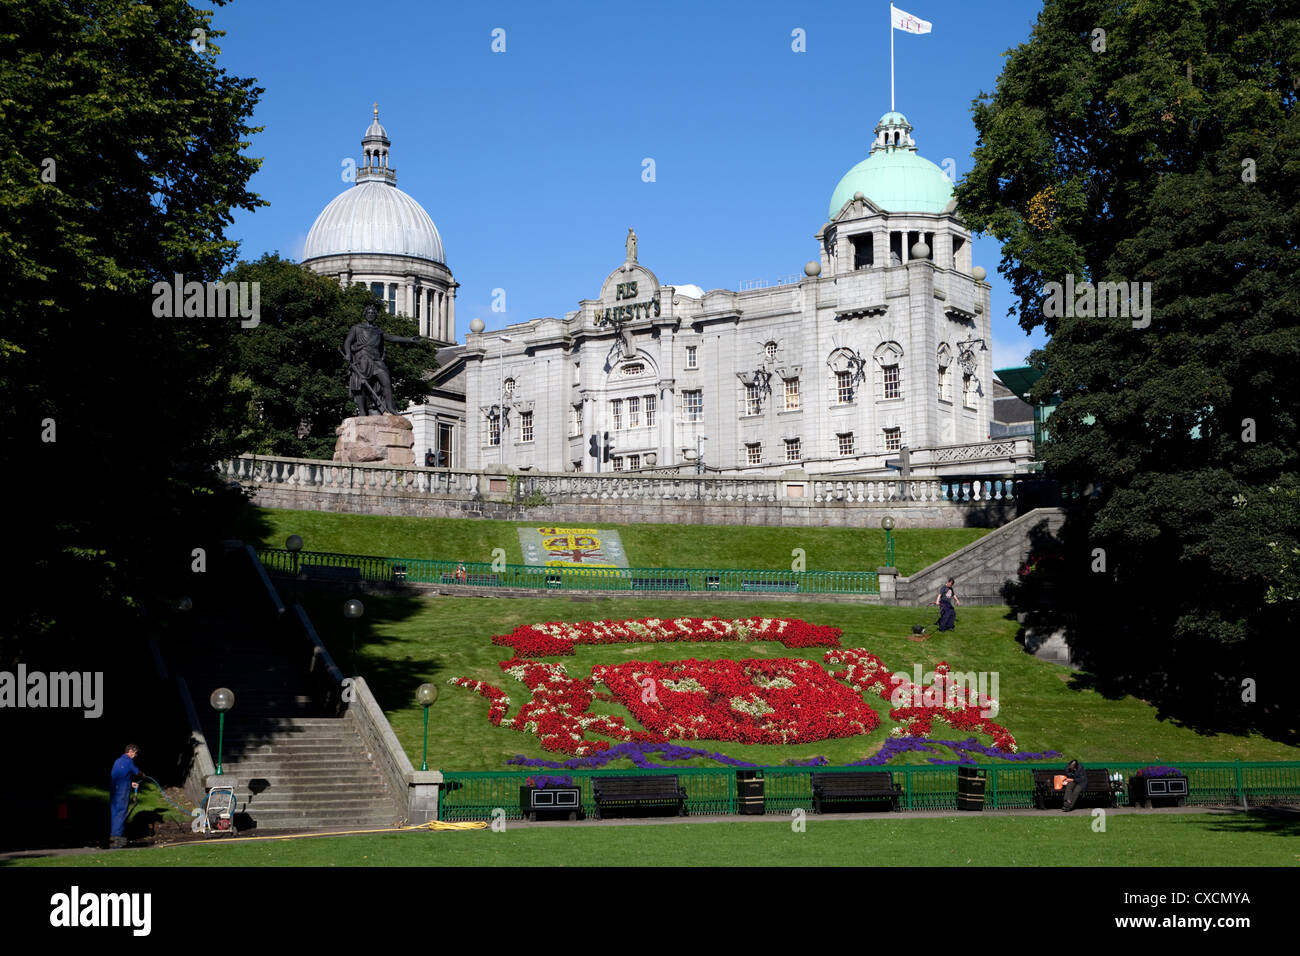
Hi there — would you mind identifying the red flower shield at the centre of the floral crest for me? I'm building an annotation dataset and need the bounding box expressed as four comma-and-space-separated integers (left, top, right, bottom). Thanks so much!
592, 658, 880, 744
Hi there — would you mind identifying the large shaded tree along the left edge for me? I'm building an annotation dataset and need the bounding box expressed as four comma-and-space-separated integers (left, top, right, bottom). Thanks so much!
0, 0, 263, 647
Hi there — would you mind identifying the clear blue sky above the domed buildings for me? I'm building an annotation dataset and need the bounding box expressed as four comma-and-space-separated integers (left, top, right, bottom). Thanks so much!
213, 0, 1043, 368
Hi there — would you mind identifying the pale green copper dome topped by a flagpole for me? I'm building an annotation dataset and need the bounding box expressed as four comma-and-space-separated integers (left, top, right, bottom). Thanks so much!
829, 112, 953, 219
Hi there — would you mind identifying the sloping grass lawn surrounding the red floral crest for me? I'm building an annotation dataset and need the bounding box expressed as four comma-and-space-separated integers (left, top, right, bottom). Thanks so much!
295, 594, 1300, 770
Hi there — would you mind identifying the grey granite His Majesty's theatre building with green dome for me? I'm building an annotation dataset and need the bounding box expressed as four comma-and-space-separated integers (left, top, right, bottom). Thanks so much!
462, 112, 1027, 475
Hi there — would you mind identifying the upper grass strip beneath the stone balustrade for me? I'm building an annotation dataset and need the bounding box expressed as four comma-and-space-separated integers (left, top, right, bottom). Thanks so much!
242, 509, 989, 575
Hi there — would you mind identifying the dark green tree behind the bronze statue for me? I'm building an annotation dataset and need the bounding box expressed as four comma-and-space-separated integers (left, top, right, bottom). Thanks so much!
228, 254, 436, 459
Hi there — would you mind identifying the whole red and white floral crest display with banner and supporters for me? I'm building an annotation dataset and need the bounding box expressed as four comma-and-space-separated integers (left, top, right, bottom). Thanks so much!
449, 618, 1017, 766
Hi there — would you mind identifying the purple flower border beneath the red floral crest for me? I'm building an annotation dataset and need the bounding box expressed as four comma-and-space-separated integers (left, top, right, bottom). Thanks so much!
506, 737, 1060, 780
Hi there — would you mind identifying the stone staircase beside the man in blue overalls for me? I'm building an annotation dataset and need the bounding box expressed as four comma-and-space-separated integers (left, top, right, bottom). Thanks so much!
172, 608, 402, 832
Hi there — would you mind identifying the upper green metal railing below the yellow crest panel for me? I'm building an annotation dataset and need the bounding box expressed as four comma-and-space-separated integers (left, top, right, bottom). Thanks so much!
257, 548, 880, 594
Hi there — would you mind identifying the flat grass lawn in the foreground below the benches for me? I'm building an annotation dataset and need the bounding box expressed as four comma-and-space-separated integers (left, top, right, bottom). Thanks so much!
12, 813, 1297, 868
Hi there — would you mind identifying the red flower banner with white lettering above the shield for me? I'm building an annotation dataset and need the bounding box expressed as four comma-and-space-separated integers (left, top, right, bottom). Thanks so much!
491, 618, 841, 657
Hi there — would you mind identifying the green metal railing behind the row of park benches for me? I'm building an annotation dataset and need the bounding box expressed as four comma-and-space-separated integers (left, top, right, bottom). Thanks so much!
438, 761, 1300, 821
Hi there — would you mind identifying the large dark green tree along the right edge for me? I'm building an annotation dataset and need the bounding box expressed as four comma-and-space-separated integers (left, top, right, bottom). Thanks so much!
957, 0, 1300, 732
